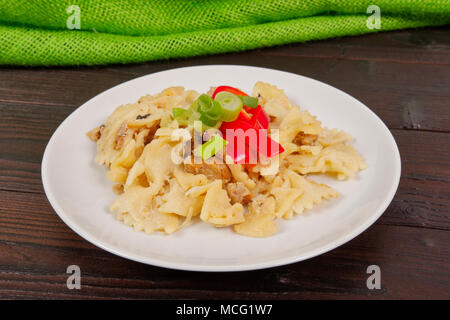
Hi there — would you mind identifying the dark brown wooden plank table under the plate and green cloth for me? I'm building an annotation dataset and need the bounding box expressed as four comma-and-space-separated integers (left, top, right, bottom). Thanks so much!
0, 27, 450, 299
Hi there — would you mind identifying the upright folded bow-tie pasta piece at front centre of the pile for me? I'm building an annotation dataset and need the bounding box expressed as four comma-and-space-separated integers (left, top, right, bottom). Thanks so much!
200, 180, 245, 227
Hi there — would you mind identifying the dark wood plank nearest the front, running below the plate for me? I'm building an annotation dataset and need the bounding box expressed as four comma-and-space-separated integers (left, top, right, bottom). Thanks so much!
0, 221, 450, 299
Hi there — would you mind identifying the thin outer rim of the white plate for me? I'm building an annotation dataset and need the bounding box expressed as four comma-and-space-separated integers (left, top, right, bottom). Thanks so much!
41, 64, 401, 272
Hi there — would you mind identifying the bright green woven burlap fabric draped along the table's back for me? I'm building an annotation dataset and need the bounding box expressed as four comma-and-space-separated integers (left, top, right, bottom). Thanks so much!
0, 0, 450, 66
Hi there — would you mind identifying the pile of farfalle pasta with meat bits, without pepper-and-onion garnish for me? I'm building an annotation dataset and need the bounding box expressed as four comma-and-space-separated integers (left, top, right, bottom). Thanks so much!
87, 82, 367, 237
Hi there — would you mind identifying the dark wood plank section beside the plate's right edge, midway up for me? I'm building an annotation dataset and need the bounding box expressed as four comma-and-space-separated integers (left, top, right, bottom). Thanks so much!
380, 130, 450, 230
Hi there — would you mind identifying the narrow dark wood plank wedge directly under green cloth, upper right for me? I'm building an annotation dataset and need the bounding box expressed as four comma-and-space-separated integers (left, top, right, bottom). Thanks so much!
261, 26, 450, 66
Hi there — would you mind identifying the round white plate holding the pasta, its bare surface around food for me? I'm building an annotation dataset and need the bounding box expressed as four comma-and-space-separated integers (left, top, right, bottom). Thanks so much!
42, 65, 400, 271
